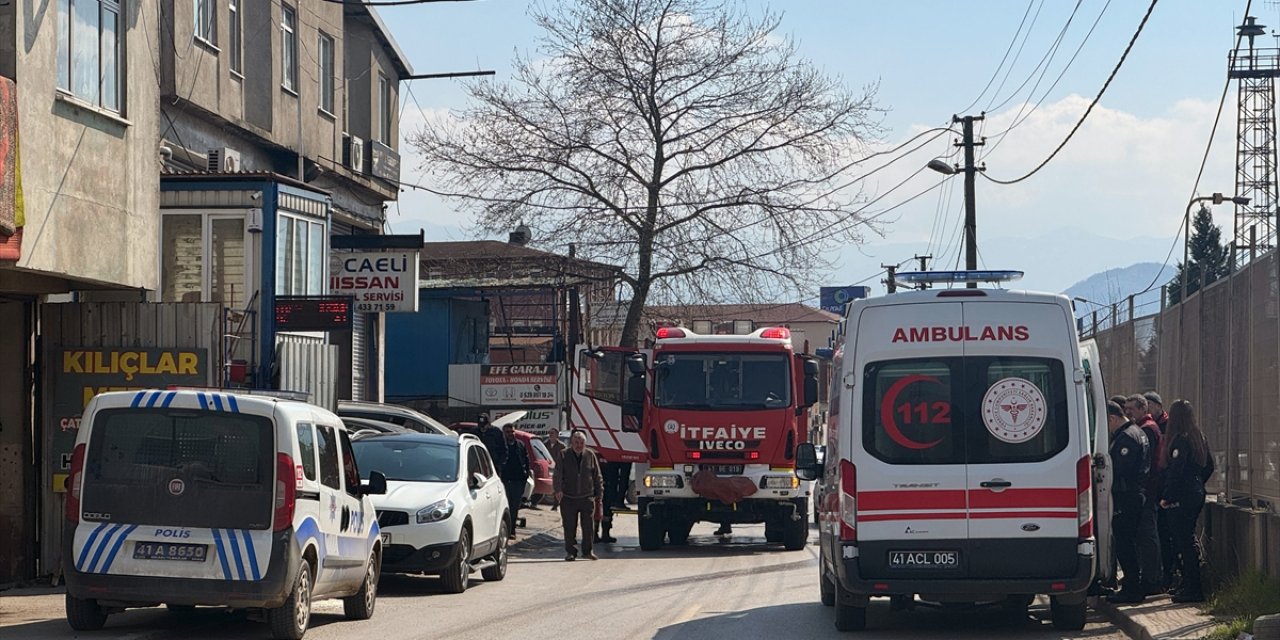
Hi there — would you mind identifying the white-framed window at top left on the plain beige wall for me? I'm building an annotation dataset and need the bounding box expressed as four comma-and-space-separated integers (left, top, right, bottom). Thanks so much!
58, 0, 124, 113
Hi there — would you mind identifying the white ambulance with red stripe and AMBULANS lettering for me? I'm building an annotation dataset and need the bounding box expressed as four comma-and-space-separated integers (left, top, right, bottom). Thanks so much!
796, 271, 1106, 631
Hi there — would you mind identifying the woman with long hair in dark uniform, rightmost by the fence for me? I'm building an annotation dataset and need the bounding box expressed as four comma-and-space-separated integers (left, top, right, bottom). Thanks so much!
1160, 399, 1213, 603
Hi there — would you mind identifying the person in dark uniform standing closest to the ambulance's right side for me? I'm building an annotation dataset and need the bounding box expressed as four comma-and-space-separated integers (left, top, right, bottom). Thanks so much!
1107, 402, 1152, 603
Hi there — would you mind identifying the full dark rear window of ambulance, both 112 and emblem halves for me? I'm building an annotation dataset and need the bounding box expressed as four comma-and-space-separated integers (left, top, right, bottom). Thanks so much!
863, 357, 1070, 465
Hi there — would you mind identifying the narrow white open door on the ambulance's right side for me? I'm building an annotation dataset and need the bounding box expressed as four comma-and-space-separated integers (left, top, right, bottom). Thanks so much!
1080, 339, 1115, 585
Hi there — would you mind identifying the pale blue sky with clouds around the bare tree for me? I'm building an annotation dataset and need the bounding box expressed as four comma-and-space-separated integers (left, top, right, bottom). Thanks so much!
380, 0, 1264, 303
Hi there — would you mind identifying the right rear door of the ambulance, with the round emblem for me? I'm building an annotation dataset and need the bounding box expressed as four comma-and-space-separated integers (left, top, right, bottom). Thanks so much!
959, 301, 1089, 579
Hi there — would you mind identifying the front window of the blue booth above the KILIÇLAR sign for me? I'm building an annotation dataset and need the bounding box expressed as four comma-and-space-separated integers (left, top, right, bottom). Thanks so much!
160, 214, 250, 308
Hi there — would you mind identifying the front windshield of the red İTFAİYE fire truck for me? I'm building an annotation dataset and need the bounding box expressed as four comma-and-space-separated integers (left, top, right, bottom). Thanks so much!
654, 353, 791, 411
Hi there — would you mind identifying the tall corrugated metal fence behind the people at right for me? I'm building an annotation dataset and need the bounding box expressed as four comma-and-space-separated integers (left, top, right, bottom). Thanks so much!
1085, 251, 1280, 508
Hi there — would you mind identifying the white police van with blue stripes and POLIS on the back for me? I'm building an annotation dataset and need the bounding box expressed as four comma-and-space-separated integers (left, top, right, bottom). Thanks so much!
63, 390, 387, 639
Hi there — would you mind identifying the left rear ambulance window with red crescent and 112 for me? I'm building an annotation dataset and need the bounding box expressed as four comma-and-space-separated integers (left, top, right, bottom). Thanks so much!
863, 358, 965, 465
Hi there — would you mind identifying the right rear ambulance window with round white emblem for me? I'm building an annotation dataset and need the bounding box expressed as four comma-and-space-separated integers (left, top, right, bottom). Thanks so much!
965, 357, 1070, 463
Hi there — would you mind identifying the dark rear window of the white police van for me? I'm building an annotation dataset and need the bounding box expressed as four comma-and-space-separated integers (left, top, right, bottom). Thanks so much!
84, 408, 275, 529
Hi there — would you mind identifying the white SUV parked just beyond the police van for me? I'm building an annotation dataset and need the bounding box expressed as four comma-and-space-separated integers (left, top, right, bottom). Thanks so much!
352, 433, 508, 594
